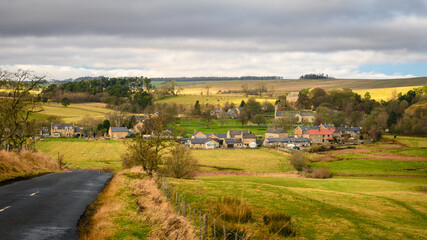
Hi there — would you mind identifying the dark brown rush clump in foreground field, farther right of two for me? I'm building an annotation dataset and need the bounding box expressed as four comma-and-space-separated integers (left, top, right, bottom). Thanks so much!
263, 212, 296, 237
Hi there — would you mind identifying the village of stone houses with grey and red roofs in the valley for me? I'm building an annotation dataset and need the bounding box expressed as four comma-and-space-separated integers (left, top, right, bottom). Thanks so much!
44, 97, 363, 149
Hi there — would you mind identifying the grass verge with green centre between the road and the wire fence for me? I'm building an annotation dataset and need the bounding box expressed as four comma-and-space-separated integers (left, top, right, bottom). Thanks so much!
79, 168, 196, 240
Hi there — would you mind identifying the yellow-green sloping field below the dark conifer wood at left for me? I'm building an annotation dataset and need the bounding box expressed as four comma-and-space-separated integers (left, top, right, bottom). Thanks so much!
41, 103, 114, 123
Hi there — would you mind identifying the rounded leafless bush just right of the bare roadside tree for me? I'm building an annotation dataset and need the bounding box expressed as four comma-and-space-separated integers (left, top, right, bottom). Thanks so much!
163, 145, 199, 178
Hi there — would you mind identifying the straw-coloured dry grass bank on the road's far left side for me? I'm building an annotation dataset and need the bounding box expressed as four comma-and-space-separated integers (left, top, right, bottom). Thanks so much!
0, 151, 61, 182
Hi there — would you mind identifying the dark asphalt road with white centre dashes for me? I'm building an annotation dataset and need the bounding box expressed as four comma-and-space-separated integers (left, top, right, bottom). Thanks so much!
0, 172, 113, 240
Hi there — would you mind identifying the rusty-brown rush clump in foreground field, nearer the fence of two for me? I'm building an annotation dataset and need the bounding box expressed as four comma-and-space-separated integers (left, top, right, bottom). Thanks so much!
215, 197, 252, 223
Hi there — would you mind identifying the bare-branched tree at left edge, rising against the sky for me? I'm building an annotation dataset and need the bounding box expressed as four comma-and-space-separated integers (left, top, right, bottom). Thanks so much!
0, 69, 45, 151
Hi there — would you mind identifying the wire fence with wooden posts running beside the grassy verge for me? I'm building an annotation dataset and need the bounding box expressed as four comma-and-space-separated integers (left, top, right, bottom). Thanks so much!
160, 178, 244, 240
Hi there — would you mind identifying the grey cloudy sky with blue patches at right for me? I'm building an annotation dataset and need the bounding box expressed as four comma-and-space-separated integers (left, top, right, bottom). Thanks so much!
0, 0, 427, 79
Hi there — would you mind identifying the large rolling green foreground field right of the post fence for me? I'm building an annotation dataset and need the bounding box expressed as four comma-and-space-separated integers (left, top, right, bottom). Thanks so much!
170, 176, 427, 239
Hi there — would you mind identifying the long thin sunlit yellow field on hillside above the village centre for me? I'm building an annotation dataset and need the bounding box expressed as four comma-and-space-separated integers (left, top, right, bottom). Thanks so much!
154, 94, 276, 106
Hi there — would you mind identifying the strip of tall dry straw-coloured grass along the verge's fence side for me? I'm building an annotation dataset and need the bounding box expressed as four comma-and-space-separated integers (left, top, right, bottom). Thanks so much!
130, 174, 197, 240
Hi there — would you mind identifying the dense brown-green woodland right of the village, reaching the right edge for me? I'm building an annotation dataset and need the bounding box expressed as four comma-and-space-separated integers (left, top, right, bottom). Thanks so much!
294, 86, 427, 138
